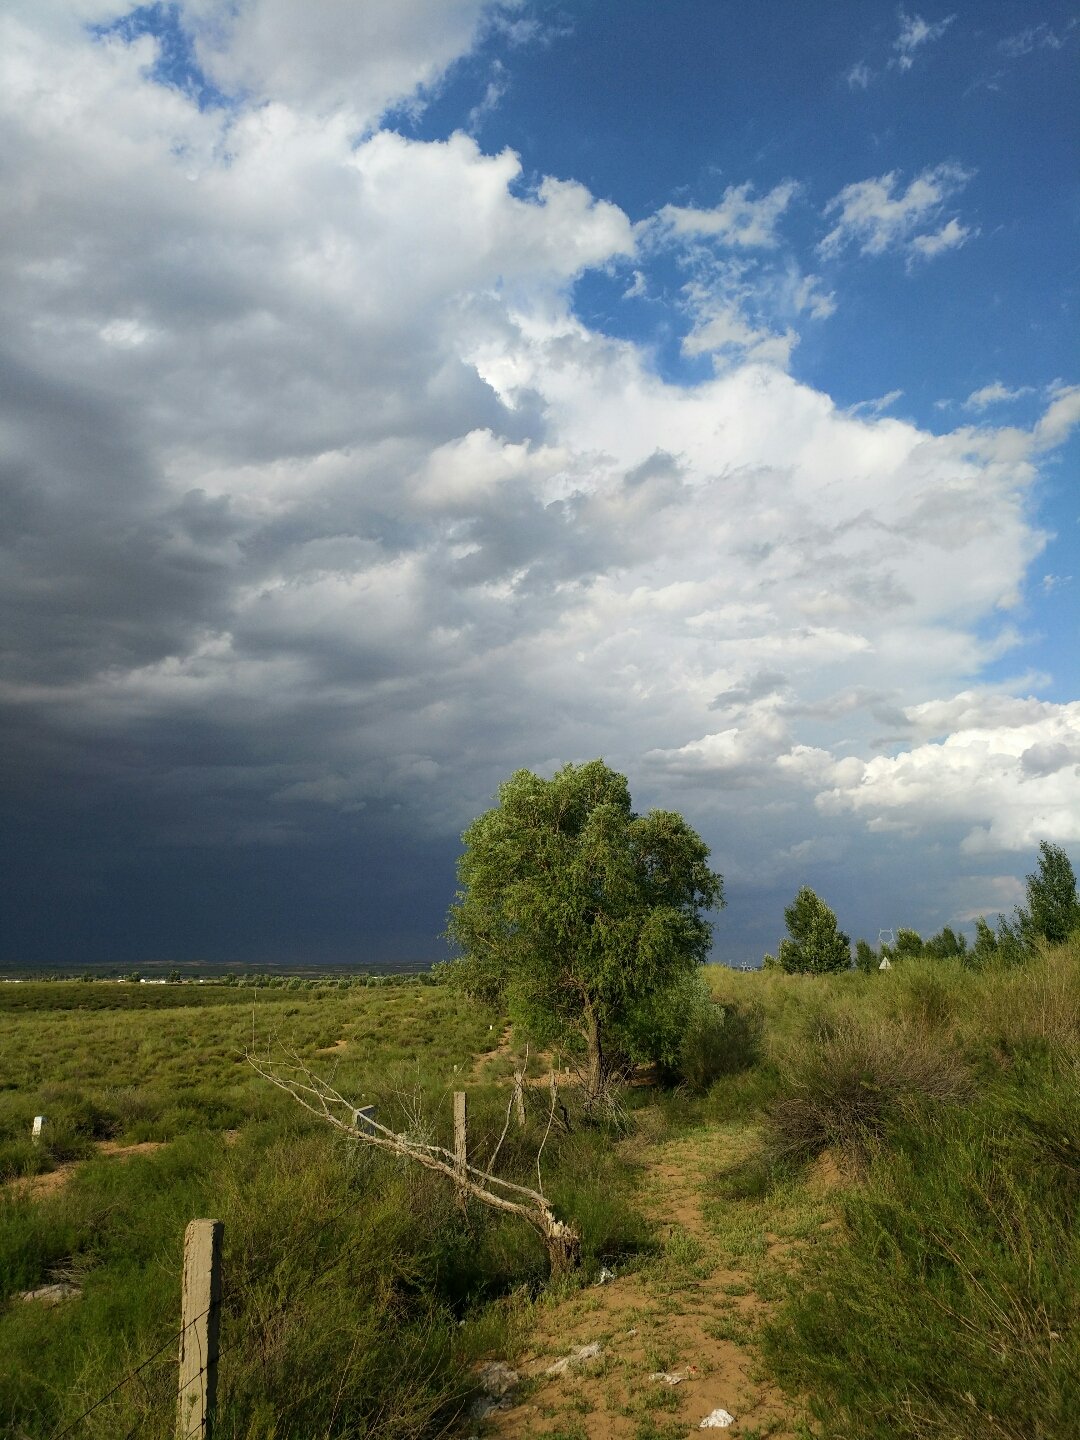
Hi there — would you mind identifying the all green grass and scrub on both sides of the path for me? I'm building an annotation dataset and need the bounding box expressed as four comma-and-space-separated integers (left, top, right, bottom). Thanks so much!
0, 948, 1080, 1440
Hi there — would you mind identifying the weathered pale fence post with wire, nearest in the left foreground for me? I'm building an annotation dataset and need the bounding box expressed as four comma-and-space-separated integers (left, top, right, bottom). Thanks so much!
176, 1220, 225, 1440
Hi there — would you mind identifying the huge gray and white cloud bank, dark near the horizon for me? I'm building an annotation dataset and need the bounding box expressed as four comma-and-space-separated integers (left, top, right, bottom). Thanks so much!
0, 0, 1080, 962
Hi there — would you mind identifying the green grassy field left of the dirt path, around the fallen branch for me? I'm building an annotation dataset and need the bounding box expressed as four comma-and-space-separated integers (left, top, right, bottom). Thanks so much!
0, 984, 651, 1440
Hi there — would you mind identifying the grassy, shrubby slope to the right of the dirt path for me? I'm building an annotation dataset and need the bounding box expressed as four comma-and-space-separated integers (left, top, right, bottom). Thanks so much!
713, 940, 1080, 1440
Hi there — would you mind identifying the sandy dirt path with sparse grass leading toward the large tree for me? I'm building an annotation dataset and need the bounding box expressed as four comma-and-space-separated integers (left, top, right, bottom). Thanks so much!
478, 1128, 822, 1440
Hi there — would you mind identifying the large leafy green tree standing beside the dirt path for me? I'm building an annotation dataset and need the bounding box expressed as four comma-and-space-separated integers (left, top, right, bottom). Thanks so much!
446, 760, 724, 1099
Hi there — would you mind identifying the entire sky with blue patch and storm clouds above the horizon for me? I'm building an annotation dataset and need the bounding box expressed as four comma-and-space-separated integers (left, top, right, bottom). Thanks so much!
0, 0, 1080, 966
